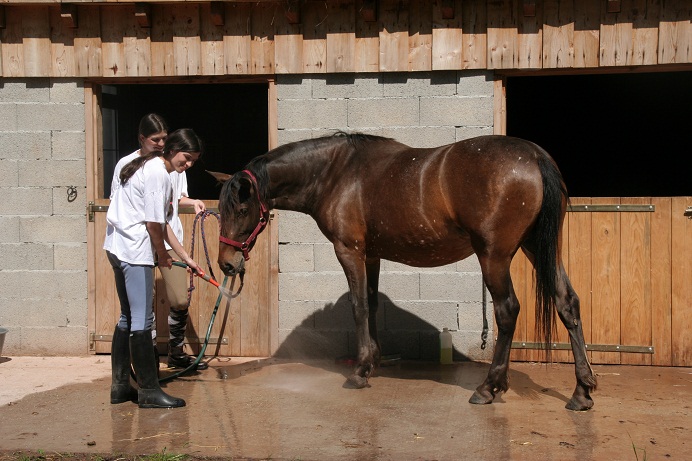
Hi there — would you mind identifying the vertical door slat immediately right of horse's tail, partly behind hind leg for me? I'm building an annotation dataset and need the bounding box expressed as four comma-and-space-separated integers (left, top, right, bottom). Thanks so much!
566, 198, 597, 362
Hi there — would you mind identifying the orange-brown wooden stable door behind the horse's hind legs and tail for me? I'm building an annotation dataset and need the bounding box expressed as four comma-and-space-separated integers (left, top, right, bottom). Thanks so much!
512, 197, 692, 366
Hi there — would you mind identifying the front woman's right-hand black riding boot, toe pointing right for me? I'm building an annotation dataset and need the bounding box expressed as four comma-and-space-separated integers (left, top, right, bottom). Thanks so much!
130, 330, 185, 408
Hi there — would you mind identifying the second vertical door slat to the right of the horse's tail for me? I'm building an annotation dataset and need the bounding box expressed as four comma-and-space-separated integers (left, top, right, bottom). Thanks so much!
591, 197, 621, 364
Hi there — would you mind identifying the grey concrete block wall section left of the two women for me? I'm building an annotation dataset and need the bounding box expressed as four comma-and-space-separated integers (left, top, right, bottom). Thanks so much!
0, 78, 88, 355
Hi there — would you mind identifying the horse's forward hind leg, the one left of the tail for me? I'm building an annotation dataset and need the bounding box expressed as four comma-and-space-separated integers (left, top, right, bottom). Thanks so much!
469, 255, 519, 404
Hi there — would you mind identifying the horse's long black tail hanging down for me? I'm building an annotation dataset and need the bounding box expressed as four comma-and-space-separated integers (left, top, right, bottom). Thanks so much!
533, 149, 569, 360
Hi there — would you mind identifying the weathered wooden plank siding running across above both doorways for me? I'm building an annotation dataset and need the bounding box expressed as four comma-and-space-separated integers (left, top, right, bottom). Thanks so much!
0, 0, 692, 77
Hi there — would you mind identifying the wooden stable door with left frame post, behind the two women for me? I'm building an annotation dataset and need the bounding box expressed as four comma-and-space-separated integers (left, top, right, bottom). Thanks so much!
86, 82, 278, 357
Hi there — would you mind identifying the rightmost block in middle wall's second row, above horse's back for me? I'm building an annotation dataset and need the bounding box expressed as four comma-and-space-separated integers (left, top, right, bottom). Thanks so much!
420, 97, 493, 126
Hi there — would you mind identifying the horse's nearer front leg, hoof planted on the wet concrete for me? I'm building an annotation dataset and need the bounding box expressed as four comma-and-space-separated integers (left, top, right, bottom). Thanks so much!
334, 243, 379, 388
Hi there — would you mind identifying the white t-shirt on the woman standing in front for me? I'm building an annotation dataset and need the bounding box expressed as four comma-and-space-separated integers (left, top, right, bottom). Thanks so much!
103, 157, 172, 266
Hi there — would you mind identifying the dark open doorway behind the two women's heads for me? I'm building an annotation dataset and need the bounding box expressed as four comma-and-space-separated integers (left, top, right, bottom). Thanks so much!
101, 83, 269, 200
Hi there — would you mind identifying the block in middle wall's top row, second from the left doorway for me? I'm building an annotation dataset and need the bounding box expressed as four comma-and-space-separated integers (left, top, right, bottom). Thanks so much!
312, 74, 384, 99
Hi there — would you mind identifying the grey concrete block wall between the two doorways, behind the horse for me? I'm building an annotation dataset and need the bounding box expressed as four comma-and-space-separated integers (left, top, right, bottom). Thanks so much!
277, 71, 493, 360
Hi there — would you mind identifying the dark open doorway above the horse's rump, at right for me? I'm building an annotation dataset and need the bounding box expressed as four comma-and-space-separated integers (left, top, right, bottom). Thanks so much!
507, 72, 692, 197
